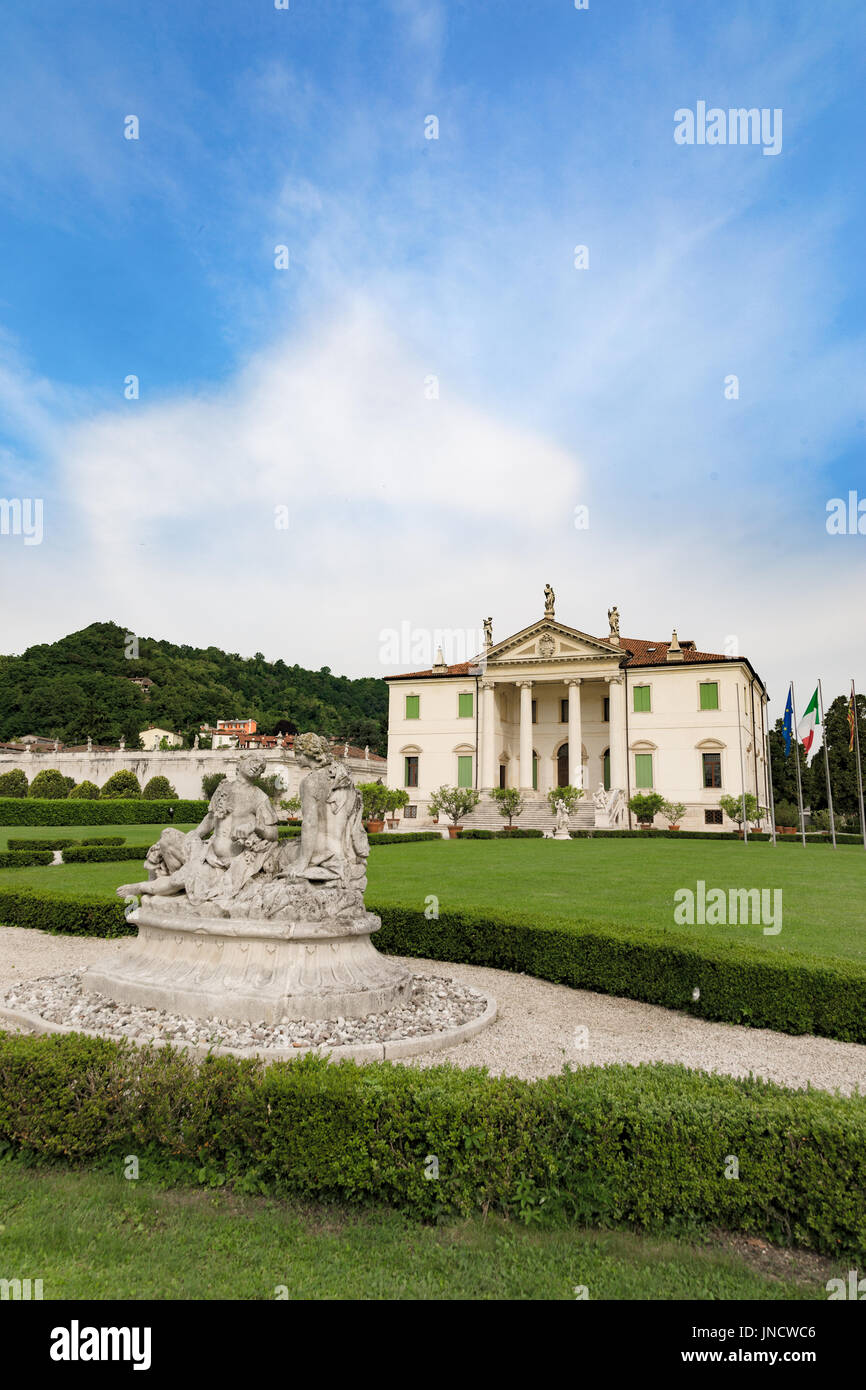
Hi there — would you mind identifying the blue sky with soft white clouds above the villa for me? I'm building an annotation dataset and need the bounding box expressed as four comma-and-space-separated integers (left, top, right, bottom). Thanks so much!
0, 0, 866, 712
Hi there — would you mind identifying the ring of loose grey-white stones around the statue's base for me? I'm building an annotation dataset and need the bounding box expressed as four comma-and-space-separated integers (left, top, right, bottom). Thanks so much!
0, 970, 488, 1051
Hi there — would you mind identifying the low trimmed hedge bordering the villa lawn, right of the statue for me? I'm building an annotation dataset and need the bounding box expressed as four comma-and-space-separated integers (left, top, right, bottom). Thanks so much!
368, 904, 866, 1043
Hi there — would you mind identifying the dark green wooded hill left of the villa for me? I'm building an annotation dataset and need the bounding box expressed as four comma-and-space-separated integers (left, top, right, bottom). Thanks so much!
0, 623, 388, 753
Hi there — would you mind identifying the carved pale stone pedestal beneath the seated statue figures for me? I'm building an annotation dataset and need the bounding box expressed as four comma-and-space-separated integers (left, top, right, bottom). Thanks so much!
82, 902, 411, 1024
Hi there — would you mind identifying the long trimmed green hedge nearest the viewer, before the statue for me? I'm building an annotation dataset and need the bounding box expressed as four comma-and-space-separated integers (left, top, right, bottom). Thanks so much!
0, 1034, 866, 1261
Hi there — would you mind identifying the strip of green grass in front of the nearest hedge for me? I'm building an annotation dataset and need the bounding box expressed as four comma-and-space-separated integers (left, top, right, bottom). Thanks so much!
0, 1162, 828, 1300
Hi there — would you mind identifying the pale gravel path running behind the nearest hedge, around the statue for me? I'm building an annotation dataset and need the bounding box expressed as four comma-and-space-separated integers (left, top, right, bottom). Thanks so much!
0, 927, 866, 1094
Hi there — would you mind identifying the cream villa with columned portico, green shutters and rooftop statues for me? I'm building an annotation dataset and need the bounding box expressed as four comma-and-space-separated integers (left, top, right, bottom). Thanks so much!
388, 585, 769, 830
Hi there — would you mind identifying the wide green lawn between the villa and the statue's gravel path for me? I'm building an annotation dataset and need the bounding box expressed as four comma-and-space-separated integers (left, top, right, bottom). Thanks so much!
0, 826, 866, 962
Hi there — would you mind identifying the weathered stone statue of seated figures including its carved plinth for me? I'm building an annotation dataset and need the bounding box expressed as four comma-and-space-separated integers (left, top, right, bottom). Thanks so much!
99, 734, 411, 1023
